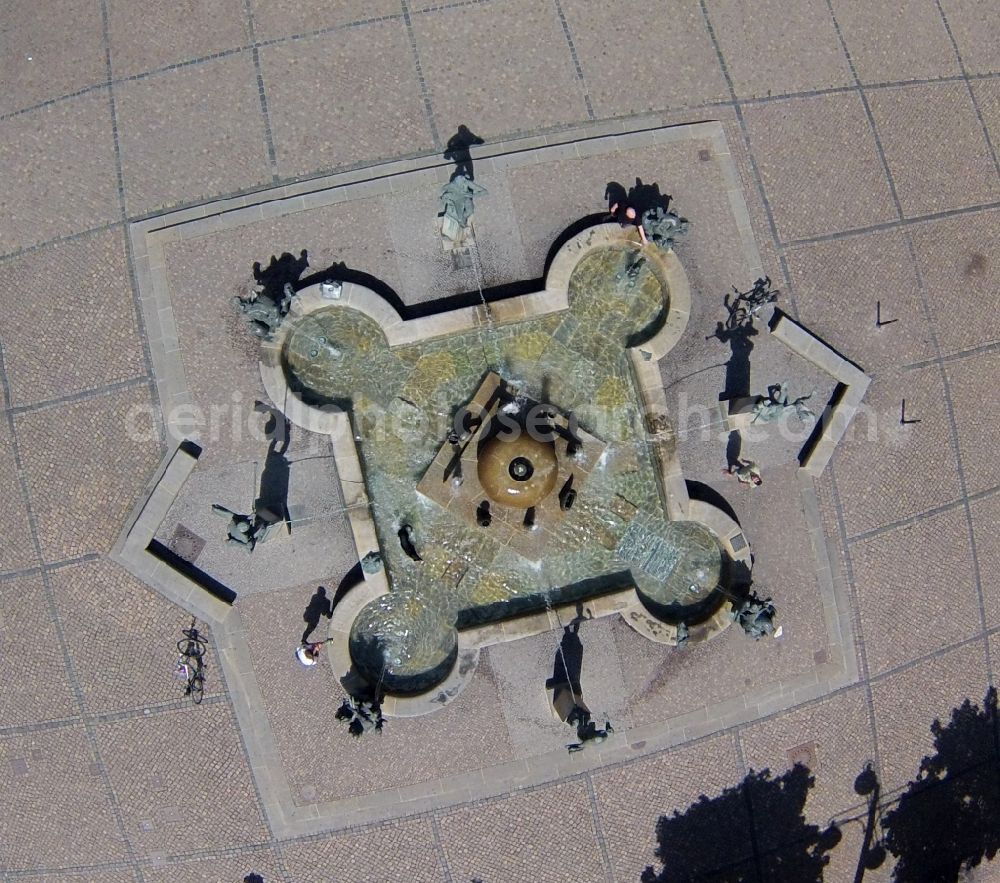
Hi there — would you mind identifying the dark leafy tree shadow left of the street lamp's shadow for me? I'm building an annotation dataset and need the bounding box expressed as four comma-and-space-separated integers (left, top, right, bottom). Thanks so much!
641, 764, 840, 883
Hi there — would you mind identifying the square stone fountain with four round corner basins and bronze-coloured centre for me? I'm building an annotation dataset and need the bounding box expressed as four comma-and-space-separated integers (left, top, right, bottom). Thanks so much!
261, 225, 749, 714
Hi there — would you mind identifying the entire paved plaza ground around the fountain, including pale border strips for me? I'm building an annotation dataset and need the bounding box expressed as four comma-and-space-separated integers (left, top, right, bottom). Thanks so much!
0, 0, 1000, 883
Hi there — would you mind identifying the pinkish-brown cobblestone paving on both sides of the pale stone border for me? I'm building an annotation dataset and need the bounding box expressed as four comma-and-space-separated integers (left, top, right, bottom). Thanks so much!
0, 0, 1000, 883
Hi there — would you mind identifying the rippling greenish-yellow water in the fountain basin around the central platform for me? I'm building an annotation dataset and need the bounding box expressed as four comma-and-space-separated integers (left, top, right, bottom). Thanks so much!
285, 248, 719, 683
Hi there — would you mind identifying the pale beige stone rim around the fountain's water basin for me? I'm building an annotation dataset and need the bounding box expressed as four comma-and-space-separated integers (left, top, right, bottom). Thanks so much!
254, 224, 708, 717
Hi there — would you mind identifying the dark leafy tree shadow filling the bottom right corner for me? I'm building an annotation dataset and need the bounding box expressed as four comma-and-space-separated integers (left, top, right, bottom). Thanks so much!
882, 687, 1000, 883
